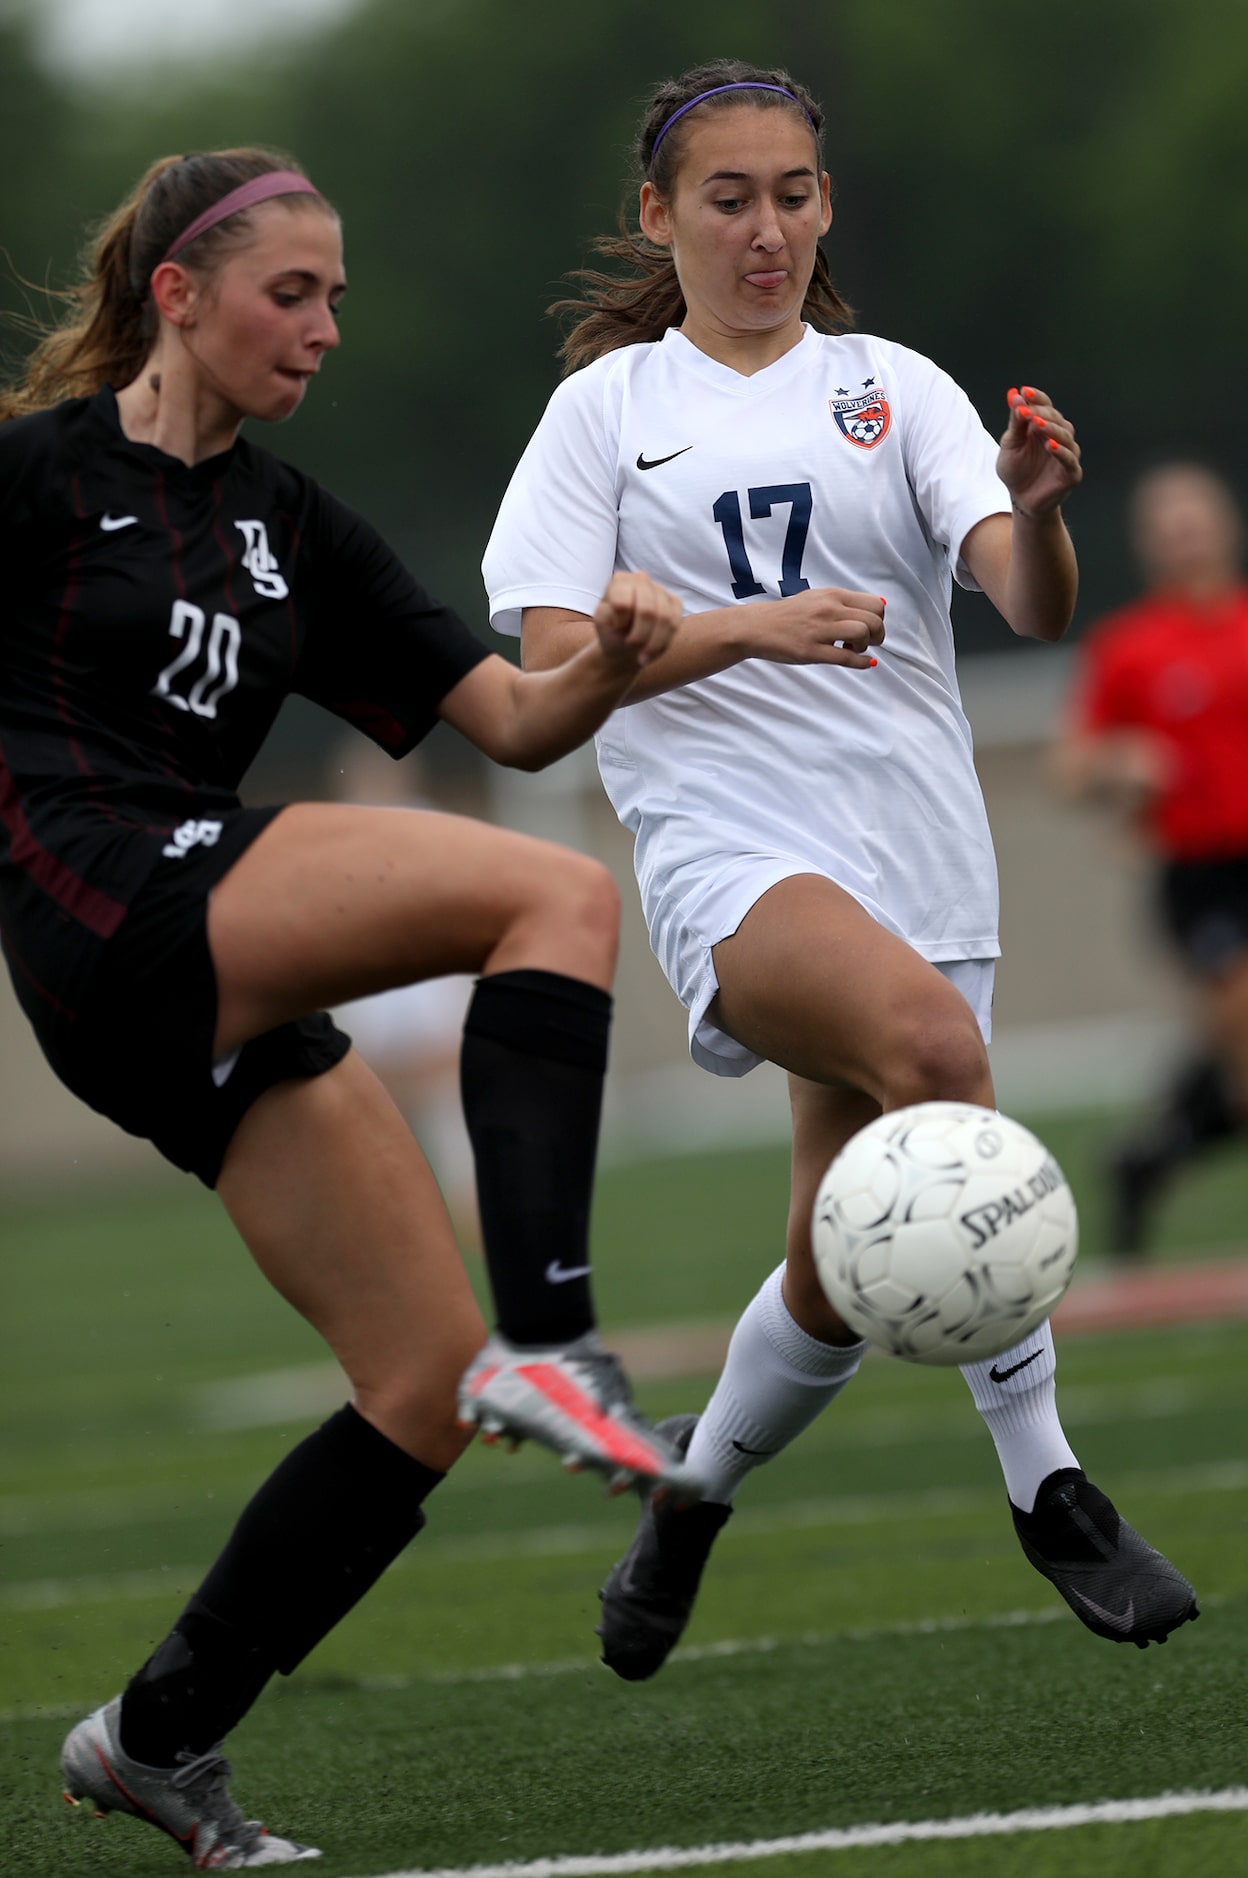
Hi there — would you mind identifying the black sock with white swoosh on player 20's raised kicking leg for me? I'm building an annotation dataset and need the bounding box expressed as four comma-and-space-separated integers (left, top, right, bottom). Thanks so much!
460, 971, 612, 1345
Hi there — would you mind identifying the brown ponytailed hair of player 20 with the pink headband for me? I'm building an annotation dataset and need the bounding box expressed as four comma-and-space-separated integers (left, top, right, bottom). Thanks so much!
0, 148, 332, 421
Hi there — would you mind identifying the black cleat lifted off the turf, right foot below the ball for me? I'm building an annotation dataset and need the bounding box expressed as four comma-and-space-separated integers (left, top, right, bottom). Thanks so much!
1010, 1467, 1201, 1649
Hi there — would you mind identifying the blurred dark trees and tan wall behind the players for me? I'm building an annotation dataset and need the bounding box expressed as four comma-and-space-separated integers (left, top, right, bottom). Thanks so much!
0, 0, 1248, 1185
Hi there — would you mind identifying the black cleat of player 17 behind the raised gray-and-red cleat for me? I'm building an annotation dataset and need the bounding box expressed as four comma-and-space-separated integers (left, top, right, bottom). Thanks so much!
597, 1414, 732, 1683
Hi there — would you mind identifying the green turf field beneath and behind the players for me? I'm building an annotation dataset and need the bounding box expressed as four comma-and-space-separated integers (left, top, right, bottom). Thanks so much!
0, 1117, 1248, 1878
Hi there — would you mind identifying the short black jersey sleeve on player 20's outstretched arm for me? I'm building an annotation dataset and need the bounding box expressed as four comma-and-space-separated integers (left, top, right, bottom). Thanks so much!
293, 488, 490, 757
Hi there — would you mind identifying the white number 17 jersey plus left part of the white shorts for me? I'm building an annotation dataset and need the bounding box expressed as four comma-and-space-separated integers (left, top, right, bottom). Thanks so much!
484, 329, 1010, 1074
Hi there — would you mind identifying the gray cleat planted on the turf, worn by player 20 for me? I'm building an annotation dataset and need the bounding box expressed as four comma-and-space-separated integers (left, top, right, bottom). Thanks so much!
60, 1696, 321, 1872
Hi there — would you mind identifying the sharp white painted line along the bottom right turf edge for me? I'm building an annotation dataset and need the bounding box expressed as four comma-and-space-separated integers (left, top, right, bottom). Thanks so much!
345, 1786, 1248, 1878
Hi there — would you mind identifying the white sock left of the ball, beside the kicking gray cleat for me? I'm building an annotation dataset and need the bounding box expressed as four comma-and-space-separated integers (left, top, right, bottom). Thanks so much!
689, 1266, 867, 1504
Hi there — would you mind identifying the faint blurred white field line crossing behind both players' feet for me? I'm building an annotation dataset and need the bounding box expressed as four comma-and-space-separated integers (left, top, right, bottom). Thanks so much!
0, 1461, 1248, 1613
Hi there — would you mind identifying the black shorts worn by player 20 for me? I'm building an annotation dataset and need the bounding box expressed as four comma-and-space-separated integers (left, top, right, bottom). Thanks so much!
36, 808, 351, 1187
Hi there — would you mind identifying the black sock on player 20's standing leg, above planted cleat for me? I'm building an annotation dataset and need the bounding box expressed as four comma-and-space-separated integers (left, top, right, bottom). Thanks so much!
120, 1407, 443, 1767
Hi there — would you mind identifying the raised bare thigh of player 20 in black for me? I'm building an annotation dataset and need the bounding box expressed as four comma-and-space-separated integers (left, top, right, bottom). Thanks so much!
208, 802, 619, 1055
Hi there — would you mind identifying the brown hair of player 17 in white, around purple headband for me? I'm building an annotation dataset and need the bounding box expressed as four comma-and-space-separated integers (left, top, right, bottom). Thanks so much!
546, 58, 854, 372
